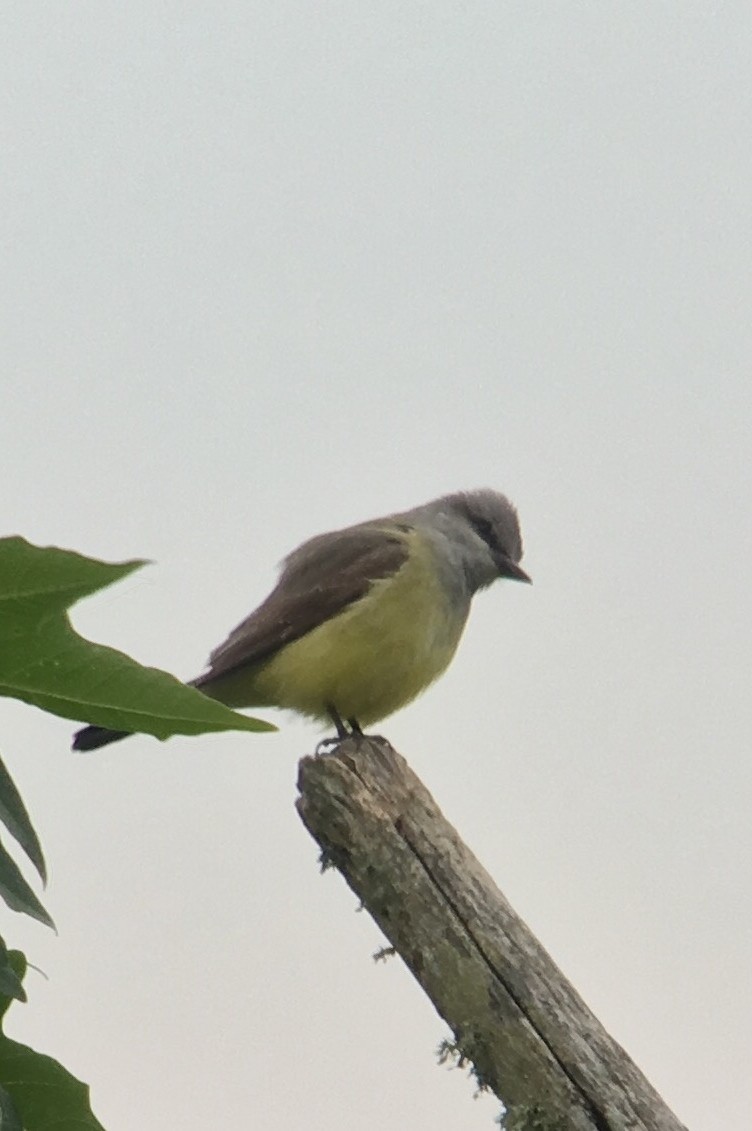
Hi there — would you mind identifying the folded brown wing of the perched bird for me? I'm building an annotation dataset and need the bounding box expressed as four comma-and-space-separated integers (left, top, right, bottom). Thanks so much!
193, 526, 408, 688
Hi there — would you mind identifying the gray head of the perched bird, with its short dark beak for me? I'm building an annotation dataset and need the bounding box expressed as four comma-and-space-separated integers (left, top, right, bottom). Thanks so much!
421, 490, 530, 590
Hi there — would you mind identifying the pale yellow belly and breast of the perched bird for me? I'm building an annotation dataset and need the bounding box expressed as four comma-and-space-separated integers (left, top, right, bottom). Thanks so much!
223, 532, 469, 726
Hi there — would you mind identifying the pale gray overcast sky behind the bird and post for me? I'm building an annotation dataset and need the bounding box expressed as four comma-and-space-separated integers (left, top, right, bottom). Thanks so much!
0, 0, 752, 1131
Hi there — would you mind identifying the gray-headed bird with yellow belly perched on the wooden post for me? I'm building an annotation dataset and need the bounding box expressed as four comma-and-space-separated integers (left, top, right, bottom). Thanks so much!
74, 491, 530, 750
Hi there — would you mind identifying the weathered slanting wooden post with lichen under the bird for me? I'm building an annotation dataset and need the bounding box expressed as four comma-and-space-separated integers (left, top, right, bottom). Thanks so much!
297, 736, 686, 1131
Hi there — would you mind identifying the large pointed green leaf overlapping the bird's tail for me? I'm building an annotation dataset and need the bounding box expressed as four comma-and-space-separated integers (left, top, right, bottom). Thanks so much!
0, 537, 277, 739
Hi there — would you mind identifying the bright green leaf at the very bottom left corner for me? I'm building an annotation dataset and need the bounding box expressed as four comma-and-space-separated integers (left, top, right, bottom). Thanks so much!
0, 950, 104, 1131
